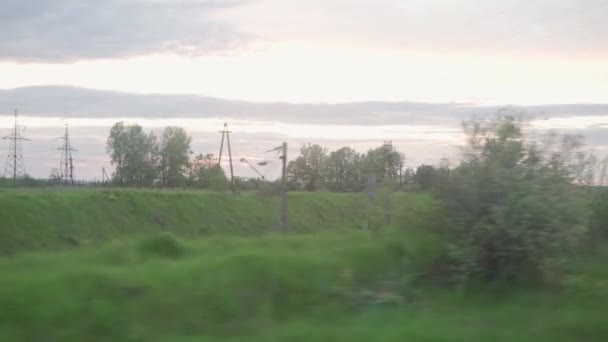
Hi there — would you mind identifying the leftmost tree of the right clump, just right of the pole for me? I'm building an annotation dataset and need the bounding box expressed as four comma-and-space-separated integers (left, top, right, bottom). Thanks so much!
287, 144, 327, 191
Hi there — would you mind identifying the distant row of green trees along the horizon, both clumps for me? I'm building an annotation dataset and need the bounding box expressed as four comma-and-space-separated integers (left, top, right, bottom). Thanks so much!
106, 122, 412, 192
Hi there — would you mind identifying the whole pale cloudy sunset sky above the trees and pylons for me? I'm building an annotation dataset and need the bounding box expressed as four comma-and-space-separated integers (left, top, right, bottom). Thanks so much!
0, 0, 608, 179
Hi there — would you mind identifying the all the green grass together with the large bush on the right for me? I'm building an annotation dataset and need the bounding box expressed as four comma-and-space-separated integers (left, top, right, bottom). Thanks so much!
0, 115, 608, 341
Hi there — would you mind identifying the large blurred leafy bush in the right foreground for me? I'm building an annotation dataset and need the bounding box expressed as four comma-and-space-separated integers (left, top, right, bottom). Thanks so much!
438, 112, 588, 281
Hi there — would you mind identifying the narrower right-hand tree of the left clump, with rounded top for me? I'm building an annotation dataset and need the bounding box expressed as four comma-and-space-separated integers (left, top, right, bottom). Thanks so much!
158, 126, 192, 187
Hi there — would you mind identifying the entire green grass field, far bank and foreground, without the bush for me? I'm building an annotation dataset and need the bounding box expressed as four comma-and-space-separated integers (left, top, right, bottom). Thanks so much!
0, 190, 608, 341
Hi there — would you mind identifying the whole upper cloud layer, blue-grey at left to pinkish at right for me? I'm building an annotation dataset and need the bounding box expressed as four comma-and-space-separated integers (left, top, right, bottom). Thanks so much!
0, 0, 608, 62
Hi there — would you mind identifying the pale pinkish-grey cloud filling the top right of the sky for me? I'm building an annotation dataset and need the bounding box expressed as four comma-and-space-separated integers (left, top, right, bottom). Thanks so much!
233, 0, 608, 56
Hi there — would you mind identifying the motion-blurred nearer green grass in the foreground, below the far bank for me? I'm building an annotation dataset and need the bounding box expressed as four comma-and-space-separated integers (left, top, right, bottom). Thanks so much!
0, 232, 608, 341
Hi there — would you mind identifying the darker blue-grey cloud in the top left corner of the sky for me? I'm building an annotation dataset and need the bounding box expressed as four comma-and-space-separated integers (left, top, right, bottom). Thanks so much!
0, 0, 245, 62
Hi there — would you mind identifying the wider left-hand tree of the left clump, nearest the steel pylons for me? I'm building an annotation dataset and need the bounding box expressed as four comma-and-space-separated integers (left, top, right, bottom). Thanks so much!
106, 122, 156, 186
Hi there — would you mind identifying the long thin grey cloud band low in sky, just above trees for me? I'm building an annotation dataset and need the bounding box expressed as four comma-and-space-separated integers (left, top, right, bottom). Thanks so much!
0, 86, 608, 126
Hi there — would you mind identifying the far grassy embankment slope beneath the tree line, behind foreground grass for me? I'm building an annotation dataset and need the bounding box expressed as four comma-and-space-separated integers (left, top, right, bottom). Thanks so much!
0, 189, 372, 254
